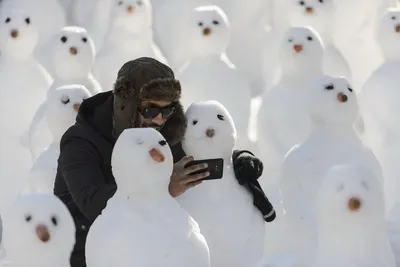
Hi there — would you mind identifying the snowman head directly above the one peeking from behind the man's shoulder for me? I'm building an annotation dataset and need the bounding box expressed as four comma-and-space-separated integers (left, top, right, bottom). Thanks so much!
52, 27, 95, 80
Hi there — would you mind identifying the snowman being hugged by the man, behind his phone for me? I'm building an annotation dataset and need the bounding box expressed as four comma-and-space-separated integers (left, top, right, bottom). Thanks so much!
177, 101, 268, 267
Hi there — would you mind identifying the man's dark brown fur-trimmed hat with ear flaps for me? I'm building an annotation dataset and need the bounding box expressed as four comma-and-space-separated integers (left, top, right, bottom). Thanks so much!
113, 57, 186, 145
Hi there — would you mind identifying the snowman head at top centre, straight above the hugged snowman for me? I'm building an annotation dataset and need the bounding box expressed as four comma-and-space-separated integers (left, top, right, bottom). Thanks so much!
185, 6, 230, 56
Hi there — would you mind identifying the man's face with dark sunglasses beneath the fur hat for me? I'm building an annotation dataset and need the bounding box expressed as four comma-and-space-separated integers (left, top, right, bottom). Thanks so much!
138, 100, 173, 130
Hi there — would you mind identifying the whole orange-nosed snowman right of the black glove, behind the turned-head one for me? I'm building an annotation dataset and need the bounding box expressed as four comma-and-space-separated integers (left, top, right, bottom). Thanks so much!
257, 27, 324, 199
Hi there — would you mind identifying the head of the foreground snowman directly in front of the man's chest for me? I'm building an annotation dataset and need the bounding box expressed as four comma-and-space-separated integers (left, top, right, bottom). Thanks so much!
111, 128, 173, 196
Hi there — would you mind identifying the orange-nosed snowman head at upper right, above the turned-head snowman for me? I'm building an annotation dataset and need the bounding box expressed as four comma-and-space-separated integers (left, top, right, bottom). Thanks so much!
280, 27, 324, 70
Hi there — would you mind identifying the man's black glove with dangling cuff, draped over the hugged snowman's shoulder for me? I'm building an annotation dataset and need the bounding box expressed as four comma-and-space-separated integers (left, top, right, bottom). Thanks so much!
232, 150, 276, 222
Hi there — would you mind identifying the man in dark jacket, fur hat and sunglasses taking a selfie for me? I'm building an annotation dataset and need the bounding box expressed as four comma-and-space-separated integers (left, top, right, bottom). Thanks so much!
54, 58, 262, 267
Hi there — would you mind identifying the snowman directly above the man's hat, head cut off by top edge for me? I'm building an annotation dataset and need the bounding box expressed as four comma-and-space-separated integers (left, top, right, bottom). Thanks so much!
93, 0, 166, 90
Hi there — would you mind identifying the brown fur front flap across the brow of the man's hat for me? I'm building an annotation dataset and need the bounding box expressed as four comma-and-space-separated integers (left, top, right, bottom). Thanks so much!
139, 78, 181, 102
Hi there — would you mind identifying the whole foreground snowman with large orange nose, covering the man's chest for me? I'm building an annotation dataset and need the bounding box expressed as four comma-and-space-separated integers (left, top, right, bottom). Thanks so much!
86, 128, 210, 267
